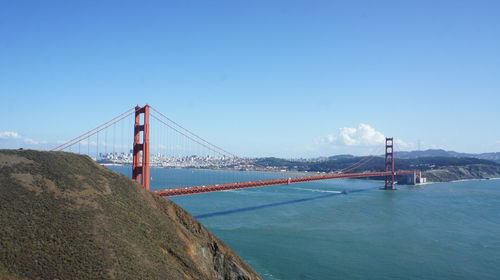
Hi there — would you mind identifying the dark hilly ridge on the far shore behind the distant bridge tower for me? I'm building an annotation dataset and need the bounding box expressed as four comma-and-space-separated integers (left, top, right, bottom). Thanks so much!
255, 150, 500, 182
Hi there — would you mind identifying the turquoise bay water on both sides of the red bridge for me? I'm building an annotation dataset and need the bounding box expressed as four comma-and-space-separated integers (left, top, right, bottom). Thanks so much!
108, 167, 500, 280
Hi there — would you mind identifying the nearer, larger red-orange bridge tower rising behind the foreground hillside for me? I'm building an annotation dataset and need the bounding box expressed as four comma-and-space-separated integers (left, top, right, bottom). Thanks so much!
132, 105, 150, 190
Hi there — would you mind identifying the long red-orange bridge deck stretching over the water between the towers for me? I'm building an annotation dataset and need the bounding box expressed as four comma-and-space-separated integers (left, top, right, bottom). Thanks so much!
153, 171, 415, 197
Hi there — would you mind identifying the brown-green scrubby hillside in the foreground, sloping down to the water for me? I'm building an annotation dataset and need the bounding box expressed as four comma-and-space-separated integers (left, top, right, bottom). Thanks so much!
0, 150, 261, 280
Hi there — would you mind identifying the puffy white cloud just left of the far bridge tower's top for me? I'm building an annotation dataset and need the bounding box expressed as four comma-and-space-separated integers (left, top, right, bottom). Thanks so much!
319, 123, 385, 147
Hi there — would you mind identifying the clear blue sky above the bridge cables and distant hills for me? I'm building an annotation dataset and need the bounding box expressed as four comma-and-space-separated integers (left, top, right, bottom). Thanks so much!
0, 0, 500, 157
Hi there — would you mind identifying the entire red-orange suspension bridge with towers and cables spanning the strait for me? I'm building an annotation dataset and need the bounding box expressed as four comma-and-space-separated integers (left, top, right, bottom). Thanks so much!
51, 105, 419, 197
